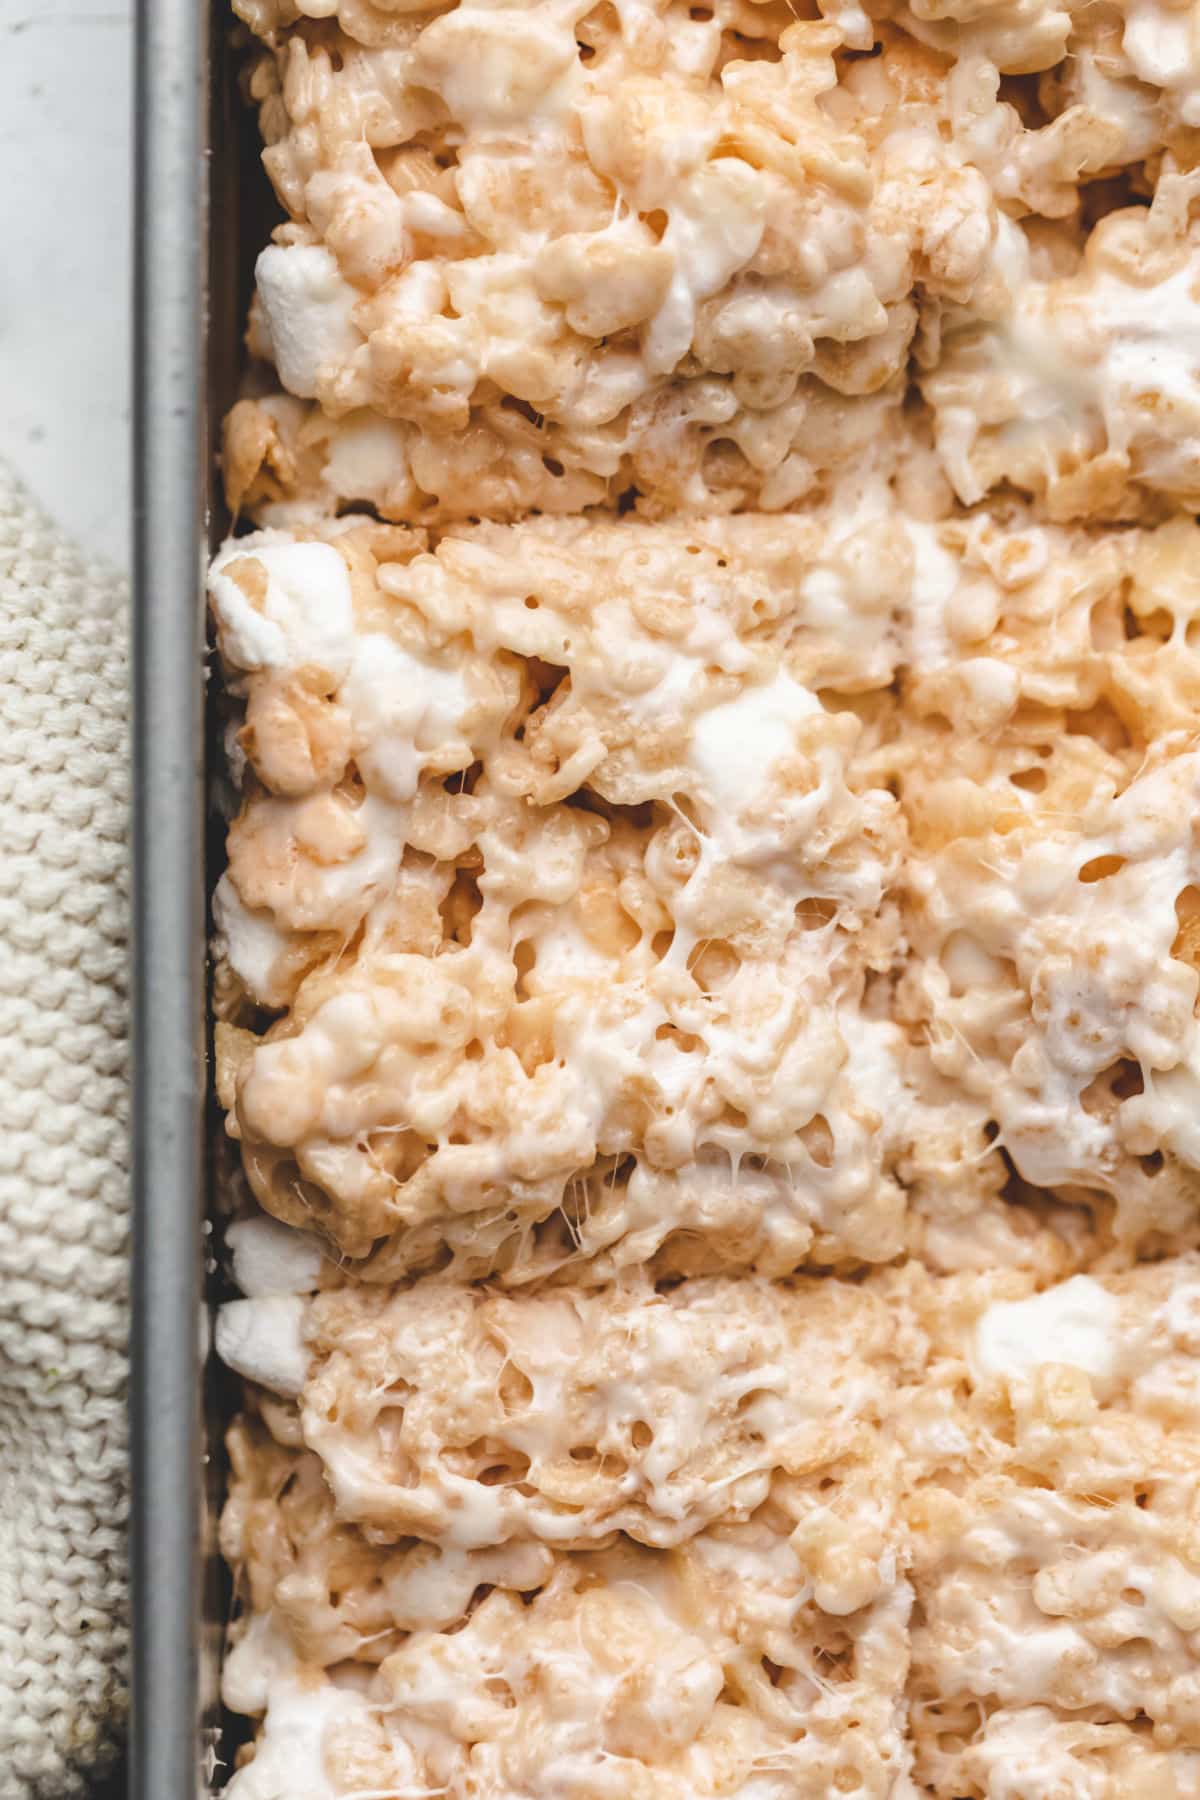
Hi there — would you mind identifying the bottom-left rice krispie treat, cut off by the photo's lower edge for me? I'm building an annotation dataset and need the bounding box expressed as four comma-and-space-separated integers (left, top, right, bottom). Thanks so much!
221, 1278, 925, 1800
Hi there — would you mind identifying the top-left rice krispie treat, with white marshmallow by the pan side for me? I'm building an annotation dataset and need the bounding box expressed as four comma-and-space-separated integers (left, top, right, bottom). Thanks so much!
218, 0, 1036, 520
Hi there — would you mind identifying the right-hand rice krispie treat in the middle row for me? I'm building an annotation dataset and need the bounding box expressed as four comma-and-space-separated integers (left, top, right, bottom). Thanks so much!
898, 515, 1200, 1255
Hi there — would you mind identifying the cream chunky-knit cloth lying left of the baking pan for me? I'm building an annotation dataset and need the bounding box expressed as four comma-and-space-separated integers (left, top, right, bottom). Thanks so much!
0, 470, 130, 1800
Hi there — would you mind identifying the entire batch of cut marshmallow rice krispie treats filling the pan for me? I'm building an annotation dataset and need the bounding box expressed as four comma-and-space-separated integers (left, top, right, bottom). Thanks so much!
209, 0, 1200, 1800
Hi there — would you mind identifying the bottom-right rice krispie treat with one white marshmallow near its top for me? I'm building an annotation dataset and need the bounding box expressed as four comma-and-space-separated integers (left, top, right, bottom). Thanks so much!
907, 1258, 1200, 1800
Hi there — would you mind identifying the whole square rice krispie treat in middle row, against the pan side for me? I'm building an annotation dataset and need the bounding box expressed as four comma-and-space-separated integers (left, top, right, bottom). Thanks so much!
212, 493, 1086, 1280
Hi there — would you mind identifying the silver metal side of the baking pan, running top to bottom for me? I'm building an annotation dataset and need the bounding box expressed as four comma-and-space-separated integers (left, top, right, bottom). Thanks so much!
130, 0, 270, 1800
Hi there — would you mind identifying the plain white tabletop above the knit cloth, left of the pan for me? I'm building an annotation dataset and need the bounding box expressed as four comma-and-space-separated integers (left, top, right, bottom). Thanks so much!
0, 0, 133, 567
